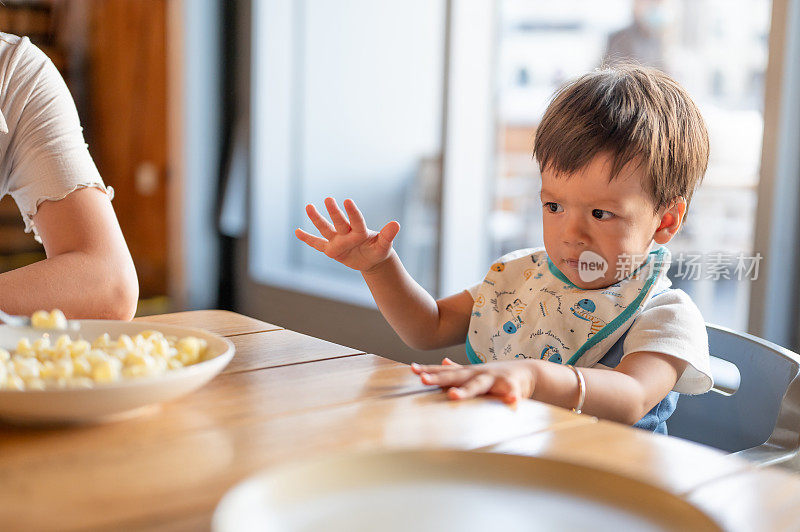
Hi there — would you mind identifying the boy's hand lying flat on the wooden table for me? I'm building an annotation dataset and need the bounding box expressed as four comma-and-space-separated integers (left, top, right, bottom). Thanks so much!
411, 358, 536, 404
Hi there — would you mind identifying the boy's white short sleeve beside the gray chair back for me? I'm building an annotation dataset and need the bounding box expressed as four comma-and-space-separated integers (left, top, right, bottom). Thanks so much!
622, 290, 714, 394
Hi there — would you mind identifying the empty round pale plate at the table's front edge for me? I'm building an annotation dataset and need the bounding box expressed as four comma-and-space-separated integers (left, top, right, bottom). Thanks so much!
213, 451, 720, 532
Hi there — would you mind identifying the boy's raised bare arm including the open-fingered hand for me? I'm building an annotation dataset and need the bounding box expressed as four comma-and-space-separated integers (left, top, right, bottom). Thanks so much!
296, 198, 472, 349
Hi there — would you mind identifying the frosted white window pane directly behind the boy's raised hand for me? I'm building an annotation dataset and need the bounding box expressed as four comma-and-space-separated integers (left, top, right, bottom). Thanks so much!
250, 0, 445, 303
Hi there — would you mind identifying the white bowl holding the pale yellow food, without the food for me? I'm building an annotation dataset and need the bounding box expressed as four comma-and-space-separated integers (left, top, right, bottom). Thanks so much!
0, 320, 234, 424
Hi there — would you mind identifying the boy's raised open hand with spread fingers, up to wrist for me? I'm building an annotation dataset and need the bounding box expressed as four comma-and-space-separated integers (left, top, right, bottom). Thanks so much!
295, 198, 400, 271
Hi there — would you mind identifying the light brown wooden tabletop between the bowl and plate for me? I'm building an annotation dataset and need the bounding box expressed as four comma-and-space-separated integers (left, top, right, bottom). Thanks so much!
0, 310, 800, 530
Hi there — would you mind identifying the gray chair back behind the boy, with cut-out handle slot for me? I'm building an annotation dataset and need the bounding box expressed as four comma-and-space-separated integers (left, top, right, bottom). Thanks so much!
667, 325, 800, 465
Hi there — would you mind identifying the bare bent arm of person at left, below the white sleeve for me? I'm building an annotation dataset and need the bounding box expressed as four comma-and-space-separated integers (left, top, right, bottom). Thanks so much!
0, 188, 139, 320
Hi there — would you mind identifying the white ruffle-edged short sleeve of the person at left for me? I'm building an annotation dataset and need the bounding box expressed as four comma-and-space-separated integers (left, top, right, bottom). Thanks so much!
3, 38, 112, 232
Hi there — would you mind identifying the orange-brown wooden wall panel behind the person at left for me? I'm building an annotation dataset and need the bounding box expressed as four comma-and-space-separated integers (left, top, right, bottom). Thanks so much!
87, 0, 169, 297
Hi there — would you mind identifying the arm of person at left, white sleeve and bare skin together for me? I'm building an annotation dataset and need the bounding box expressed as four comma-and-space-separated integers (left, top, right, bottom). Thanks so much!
0, 38, 138, 319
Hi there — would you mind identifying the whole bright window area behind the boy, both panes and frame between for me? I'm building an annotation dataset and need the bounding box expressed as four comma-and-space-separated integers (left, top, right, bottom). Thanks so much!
249, 0, 771, 330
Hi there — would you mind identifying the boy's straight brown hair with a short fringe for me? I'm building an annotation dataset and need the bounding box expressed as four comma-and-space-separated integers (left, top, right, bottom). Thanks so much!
533, 65, 709, 211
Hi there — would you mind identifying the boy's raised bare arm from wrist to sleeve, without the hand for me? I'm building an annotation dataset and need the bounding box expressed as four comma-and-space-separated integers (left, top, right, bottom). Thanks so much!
361, 251, 473, 349
